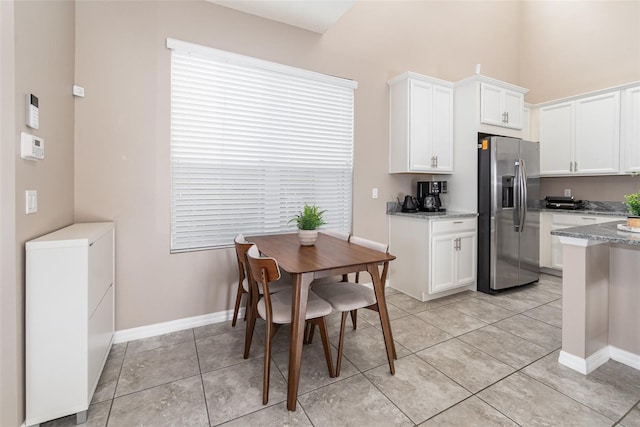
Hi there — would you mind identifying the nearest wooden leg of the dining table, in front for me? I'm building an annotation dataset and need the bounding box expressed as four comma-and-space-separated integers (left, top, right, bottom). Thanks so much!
287, 273, 313, 411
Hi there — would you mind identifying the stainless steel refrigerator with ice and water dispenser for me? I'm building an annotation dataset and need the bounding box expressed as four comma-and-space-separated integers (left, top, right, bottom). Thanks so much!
478, 134, 540, 293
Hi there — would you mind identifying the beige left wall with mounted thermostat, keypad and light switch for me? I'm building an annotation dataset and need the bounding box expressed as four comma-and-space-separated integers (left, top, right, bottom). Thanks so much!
0, 0, 75, 426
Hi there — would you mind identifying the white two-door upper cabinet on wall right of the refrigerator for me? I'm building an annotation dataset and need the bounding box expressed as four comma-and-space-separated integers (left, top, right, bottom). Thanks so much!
540, 91, 620, 176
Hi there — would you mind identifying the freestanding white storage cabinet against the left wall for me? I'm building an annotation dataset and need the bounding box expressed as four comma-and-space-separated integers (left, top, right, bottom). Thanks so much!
25, 222, 114, 426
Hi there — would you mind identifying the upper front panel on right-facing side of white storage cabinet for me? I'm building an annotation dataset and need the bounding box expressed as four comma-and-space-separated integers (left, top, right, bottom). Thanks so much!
87, 230, 113, 316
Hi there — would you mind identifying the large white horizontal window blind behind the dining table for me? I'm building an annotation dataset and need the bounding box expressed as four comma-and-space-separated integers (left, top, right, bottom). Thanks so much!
167, 39, 357, 252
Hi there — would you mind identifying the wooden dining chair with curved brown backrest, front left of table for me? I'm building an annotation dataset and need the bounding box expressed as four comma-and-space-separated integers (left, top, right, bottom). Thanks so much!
247, 245, 335, 405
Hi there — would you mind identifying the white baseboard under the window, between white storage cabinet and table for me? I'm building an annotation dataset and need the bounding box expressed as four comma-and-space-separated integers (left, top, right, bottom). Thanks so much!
113, 307, 244, 344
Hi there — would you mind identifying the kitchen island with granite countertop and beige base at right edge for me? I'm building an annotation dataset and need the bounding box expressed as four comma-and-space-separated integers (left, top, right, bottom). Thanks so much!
551, 221, 640, 374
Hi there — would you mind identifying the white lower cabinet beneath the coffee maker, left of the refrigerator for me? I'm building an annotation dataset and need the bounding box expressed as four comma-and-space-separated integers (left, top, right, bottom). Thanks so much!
389, 215, 477, 301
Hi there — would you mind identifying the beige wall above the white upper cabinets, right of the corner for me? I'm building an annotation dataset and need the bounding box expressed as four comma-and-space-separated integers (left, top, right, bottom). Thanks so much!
520, 0, 640, 103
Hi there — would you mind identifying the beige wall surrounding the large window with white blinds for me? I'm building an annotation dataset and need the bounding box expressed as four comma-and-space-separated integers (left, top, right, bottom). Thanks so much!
75, 1, 519, 329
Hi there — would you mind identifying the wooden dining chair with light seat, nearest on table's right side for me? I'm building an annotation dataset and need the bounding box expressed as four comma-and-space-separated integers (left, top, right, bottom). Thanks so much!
307, 236, 397, 377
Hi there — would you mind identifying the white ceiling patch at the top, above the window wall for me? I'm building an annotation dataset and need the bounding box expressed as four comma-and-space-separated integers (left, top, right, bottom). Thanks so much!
207, 0, 356, 34
